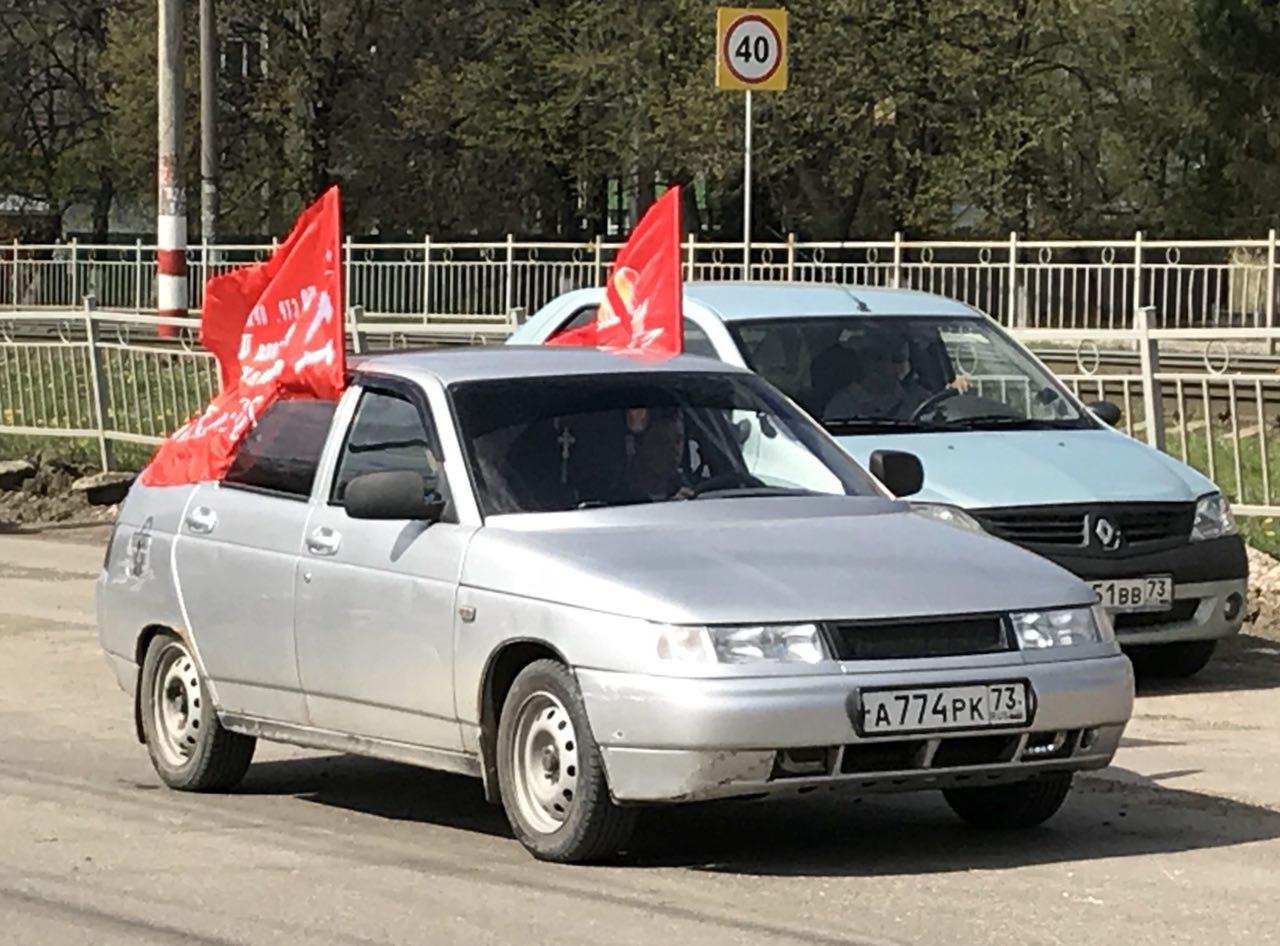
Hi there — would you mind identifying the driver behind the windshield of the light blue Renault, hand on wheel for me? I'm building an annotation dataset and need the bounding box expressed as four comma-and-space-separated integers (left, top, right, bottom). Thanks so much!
822, 329, 969, 420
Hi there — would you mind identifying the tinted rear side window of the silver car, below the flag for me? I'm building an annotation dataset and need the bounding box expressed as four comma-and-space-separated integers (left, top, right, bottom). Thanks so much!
223, 401, 338, 499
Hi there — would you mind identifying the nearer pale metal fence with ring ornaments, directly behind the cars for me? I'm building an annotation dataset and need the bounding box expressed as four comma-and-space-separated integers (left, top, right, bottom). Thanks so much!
0, 309, 1280, 515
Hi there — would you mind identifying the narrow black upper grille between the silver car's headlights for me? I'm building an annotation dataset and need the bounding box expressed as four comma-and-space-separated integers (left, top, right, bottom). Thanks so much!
827, 614, 1015, 661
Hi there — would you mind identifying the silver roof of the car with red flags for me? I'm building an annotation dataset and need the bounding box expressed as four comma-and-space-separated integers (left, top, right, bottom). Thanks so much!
352, 344, 748, 384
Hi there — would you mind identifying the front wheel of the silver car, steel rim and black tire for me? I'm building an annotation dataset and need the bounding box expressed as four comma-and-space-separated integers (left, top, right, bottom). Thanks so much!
498, 661, 635, 864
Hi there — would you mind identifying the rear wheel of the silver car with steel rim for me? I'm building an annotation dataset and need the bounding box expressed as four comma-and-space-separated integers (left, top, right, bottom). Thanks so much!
138, 634, 257, 791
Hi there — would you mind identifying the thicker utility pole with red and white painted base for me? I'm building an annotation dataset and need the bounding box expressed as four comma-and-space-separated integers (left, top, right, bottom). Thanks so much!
156, 0, 187, 335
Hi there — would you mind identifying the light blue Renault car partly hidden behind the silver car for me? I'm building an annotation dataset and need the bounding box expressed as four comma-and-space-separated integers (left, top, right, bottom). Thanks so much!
509, 283, 1248, 676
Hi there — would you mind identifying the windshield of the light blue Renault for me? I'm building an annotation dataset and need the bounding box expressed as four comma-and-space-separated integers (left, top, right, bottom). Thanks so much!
730, 316, 1094, 434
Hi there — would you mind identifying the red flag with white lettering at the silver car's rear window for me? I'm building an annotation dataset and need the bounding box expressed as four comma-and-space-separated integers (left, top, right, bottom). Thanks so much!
142, 187, 347, 486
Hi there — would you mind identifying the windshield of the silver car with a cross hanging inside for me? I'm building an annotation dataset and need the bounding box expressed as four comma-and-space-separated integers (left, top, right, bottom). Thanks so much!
449, 371, 878, 516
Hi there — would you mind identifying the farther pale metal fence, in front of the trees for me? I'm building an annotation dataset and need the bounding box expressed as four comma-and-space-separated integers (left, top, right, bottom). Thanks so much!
0, 230, 1280, 330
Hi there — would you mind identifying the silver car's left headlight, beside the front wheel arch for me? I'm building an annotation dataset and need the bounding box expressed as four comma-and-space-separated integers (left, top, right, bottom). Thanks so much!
658, 625, 829, 663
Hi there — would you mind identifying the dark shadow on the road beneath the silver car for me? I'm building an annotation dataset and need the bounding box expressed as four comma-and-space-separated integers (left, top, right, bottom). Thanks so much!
232, 755, 1280, 877
